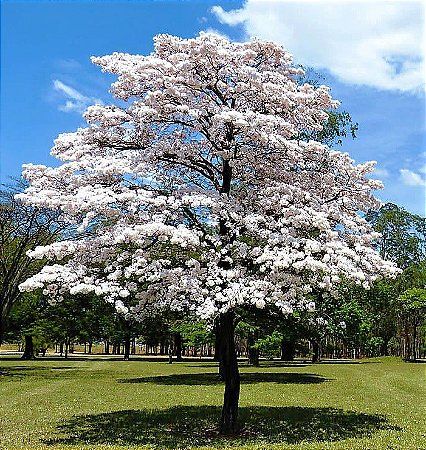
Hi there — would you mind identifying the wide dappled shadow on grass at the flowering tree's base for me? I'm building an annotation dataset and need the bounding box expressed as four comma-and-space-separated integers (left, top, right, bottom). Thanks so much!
43, 406, 395, 449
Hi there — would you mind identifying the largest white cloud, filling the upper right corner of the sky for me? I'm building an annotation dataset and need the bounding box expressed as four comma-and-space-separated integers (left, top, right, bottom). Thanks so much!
212, 0, 425, 92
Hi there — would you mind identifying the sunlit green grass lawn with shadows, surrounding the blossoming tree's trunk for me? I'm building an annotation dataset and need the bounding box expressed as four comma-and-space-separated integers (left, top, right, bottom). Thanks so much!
0, 357, 426, 450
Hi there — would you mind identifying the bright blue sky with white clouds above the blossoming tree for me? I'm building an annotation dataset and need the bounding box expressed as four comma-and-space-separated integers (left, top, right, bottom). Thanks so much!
0, 0, 426, 215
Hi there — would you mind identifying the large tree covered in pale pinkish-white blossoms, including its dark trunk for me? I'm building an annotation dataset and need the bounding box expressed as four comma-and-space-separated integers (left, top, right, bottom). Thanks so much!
20, 34, 396, 433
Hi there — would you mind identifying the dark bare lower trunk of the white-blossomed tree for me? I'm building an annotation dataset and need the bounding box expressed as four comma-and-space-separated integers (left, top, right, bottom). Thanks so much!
218, 311, 240, 435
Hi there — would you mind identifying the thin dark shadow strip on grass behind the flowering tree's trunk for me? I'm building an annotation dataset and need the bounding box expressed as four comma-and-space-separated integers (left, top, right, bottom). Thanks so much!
117, 372, 330, 386
